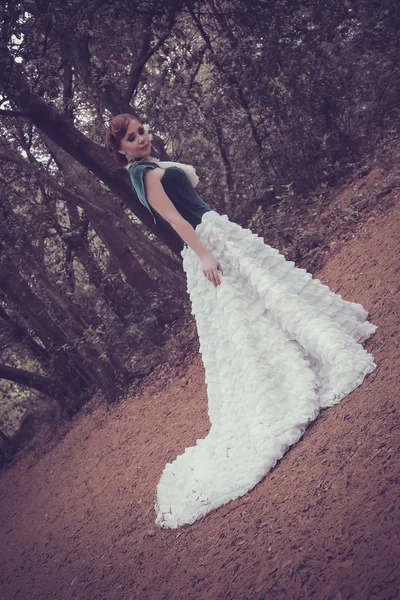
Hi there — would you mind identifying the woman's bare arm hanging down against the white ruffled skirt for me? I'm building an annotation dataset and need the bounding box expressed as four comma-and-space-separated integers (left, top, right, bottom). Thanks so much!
144, 169, 222, 286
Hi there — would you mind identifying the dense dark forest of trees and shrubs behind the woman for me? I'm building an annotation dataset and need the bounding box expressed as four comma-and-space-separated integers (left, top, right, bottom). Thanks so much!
0, 0, 400, 459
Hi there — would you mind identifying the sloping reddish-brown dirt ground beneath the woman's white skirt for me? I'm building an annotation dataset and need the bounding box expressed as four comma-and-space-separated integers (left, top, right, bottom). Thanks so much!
0, 176, 400, 600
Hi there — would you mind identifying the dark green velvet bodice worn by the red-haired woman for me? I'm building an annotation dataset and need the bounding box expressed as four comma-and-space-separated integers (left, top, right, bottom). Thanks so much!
127, 161, 213, 246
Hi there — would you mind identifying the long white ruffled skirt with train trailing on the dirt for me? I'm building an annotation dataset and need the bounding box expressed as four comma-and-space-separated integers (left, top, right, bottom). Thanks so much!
155, 211, 377, 528
